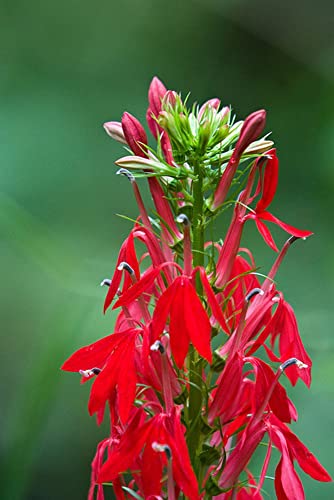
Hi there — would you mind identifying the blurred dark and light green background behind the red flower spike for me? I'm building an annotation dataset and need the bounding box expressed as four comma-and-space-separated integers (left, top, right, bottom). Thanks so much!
0, 0, 334, 500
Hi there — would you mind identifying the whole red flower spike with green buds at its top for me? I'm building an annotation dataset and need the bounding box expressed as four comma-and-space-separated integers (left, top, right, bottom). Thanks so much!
62, 77, 331, 500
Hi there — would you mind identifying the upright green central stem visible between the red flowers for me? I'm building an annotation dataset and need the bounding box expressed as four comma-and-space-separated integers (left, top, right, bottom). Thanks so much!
187, 162, 204, 475
